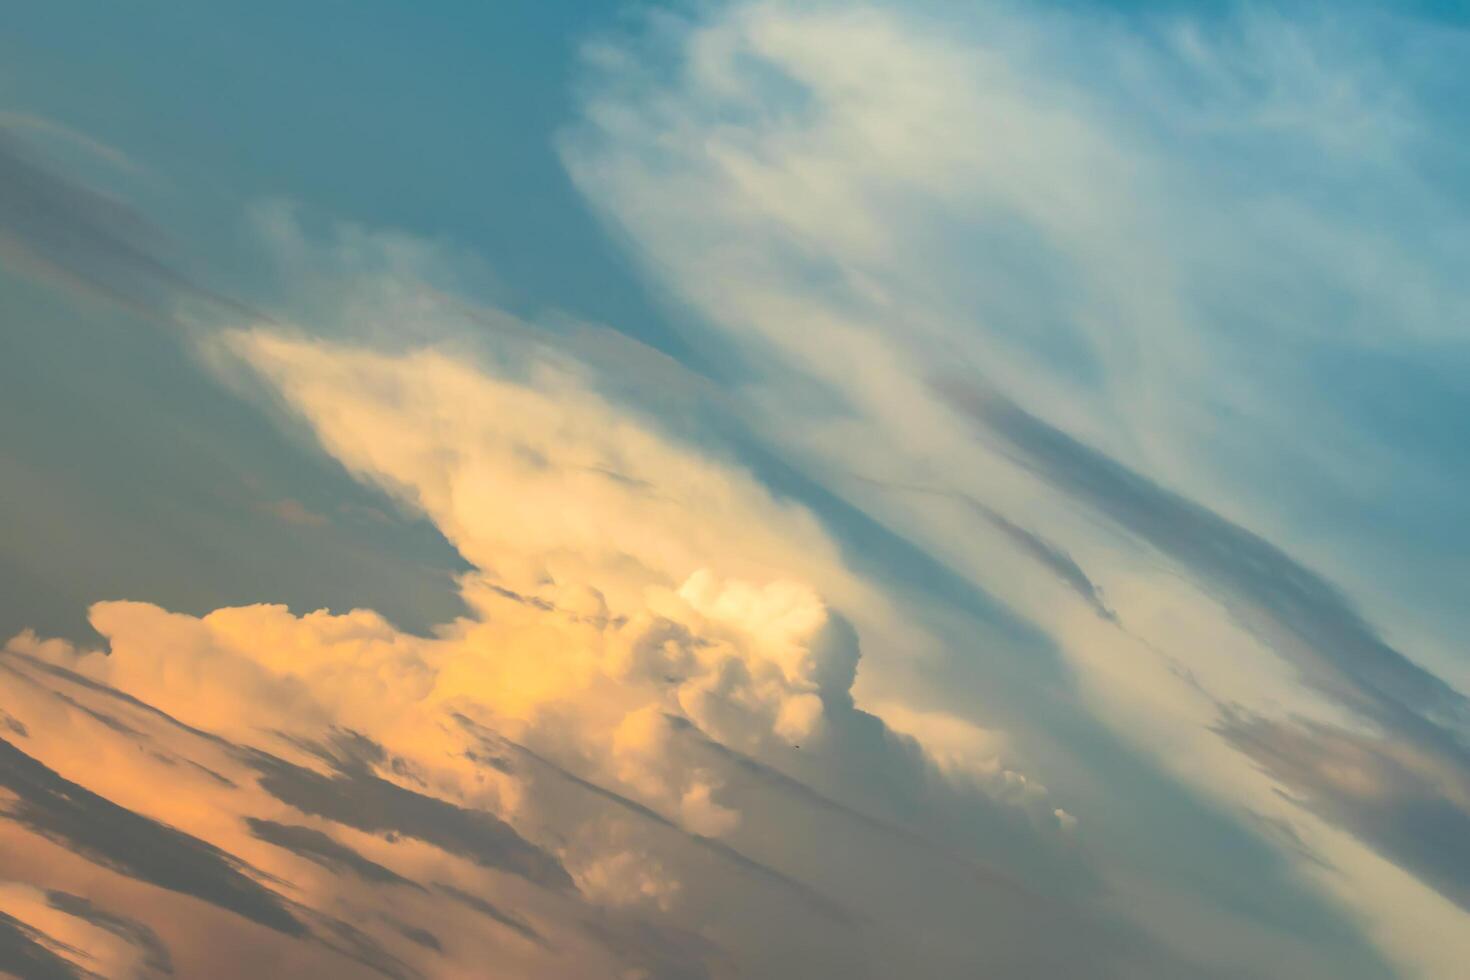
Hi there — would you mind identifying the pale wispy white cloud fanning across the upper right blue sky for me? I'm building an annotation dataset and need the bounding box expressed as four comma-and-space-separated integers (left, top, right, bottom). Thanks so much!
563, 3, 1467, 974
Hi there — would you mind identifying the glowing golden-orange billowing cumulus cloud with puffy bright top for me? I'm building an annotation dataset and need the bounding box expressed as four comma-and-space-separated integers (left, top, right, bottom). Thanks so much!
6, 308, 1135, 976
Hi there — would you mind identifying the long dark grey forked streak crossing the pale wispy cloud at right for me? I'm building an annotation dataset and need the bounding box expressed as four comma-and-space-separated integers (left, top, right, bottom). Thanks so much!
936, 381, 1470, 909
